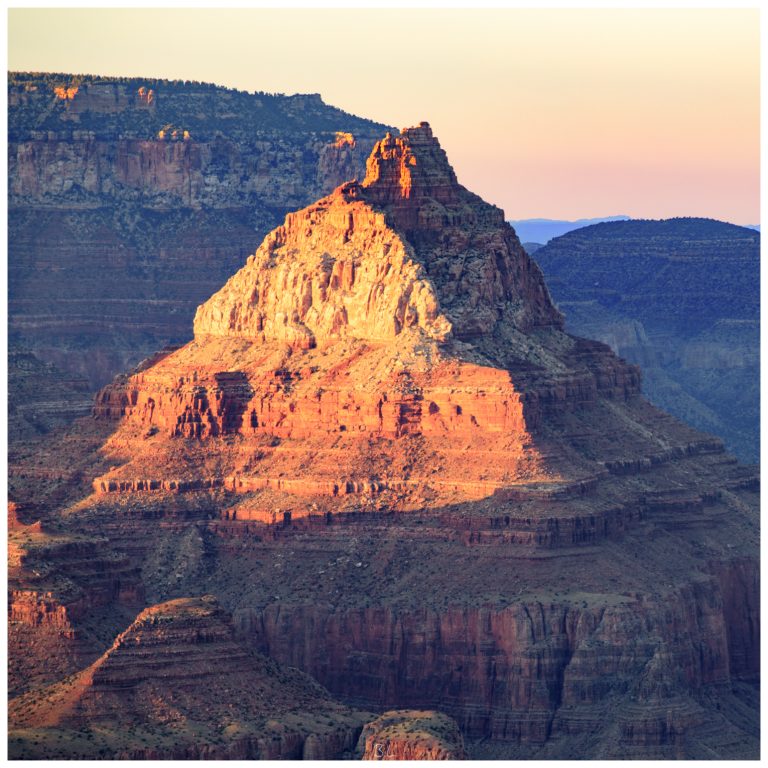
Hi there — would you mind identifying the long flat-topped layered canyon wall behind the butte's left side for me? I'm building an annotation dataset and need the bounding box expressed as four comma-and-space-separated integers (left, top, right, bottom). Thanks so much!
8, 73, 390, 389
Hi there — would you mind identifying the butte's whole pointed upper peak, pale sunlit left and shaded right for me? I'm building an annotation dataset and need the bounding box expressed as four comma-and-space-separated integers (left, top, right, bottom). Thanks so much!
195, 123, 562, 349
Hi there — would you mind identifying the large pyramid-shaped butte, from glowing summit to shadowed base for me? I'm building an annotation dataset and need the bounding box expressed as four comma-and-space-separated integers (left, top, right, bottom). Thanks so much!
11, 123, 759, 759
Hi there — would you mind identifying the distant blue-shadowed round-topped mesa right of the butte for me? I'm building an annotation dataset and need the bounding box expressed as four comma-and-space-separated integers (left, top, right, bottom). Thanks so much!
536, 219, 760, 463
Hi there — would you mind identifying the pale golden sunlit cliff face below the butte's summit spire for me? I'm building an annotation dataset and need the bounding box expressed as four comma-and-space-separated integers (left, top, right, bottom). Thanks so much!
194, 187, 451, 349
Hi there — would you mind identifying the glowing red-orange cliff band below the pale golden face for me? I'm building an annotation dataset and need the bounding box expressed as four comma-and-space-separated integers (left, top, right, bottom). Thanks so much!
94, 343, 537, 439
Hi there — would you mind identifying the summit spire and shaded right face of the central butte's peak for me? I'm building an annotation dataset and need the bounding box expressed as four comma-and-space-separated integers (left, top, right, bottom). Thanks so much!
353, 123, 562, 339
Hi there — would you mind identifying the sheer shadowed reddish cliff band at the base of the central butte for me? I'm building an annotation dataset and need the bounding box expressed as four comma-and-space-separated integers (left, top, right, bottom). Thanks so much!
242, 556, 759, 758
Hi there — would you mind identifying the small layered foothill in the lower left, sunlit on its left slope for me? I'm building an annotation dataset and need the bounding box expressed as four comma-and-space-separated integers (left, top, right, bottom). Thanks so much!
9, 597, 372, 760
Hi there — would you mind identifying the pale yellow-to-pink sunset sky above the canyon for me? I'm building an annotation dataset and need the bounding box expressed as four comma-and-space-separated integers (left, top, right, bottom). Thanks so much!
8, 8, 760, 224
